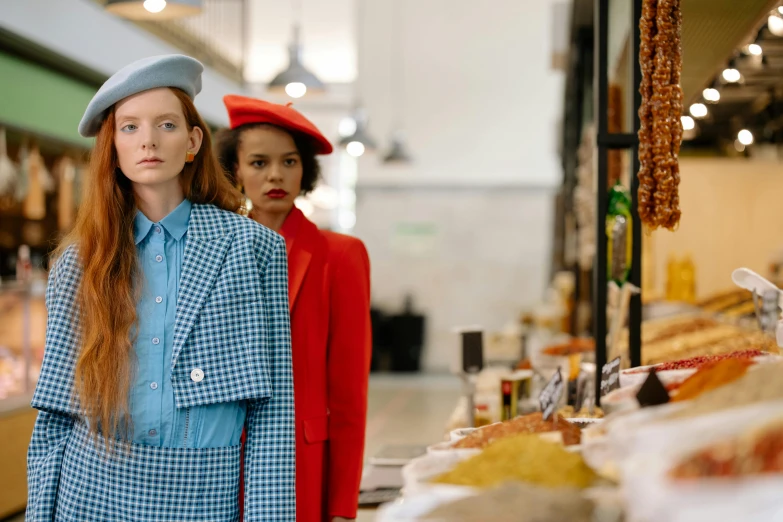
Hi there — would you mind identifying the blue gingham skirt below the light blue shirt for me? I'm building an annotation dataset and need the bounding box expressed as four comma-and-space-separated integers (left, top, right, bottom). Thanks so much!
55, 422, 240, 522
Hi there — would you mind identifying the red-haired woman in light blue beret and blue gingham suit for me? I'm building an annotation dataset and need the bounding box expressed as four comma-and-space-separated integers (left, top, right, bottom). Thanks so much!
27, 55, 295, 522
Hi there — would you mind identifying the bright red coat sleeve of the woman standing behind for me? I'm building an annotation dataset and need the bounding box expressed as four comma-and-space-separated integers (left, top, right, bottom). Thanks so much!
327, 240, 372, 518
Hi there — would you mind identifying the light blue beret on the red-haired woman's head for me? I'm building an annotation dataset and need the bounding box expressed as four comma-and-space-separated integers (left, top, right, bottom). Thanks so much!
79, 54, 204, 138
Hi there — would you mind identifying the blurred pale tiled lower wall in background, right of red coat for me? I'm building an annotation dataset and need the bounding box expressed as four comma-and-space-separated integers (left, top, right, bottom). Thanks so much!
355, 187, 554, 370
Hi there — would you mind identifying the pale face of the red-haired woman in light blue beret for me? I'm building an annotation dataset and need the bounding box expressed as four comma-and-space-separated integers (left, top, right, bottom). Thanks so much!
114, 88, 204, 188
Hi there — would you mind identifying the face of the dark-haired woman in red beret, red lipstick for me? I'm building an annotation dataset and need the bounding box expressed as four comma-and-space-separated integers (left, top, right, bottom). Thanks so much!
236, 125, 302, 215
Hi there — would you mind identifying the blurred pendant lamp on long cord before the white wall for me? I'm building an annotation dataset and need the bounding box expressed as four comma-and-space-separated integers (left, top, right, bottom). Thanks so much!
383, 0, 411, 165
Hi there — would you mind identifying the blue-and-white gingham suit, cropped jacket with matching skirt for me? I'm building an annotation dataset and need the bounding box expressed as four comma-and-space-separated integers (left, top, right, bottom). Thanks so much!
27, 204, 295, 522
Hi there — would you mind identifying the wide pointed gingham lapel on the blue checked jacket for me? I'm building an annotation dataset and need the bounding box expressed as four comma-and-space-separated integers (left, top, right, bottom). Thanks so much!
171, 205, 234, 368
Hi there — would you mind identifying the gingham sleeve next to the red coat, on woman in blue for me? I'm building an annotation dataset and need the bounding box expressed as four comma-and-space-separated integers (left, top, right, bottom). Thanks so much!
244, 237, 296, 522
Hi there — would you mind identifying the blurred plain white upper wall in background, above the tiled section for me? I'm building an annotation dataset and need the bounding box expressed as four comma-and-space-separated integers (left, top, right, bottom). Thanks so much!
358, 0, 563, 185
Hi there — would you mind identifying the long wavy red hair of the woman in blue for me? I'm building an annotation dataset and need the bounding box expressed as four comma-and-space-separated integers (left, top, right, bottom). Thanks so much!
59, 88, 243, 443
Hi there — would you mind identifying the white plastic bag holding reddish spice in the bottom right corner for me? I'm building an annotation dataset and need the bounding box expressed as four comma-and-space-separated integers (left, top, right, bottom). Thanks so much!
618, 401, 783, 522
